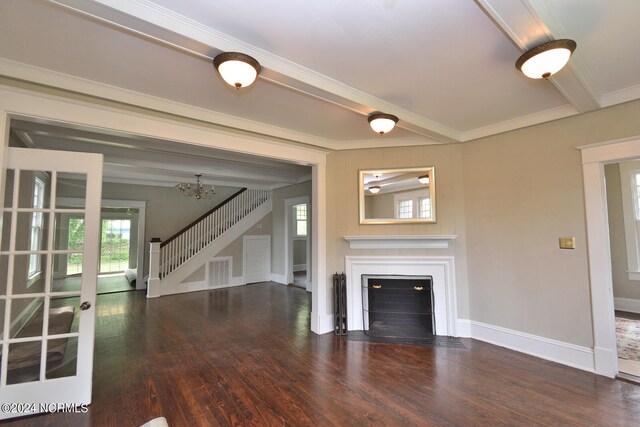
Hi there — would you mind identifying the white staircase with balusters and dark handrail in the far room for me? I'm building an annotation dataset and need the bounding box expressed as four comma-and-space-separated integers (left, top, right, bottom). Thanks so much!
147, 188, 271, 297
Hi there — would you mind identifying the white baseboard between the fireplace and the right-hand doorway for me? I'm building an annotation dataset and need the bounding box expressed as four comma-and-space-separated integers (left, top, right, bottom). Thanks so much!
458, 320, 595, 372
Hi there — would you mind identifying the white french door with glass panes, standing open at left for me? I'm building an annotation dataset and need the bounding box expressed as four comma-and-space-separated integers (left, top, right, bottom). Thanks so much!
0, 148, 102, 419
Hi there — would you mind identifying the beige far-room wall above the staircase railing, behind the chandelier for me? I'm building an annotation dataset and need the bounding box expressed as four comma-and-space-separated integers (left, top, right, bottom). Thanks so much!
58, 182, 239, 275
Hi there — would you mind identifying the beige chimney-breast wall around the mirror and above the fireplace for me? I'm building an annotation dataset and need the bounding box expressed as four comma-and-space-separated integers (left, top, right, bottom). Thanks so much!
327, 144, 469, 318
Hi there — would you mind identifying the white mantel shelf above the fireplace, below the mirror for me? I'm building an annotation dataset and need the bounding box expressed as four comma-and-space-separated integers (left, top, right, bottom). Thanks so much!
344, 234, 458, 249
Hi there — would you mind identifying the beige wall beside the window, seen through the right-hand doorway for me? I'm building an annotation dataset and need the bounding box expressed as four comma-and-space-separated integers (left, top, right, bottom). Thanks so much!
604, 163, 640, 300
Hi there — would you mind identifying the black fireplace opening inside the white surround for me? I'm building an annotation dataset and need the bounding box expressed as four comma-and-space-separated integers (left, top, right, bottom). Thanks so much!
362, 274, 436, 338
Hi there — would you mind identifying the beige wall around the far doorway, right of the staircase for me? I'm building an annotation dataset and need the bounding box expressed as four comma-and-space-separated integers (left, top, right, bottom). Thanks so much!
271, 181, 313, 274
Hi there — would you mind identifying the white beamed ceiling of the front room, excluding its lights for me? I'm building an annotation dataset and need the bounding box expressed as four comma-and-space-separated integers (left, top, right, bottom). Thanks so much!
0, 0, 640, 179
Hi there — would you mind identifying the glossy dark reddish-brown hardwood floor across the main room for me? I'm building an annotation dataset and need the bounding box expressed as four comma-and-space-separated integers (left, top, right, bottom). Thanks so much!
7, 284, 640, 427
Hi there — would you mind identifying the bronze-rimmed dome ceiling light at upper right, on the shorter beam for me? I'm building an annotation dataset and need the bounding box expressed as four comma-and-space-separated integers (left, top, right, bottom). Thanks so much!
516, 39, 576, 79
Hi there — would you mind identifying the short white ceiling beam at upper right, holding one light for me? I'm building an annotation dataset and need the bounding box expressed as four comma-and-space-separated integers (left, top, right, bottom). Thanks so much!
476, 0, 602, 113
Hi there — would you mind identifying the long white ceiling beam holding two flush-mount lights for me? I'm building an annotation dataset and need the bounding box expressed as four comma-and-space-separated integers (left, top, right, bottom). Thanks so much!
49, 0, 462, 142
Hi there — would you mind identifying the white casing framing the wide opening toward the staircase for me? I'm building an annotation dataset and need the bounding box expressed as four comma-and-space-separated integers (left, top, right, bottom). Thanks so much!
0, 85, 333, 334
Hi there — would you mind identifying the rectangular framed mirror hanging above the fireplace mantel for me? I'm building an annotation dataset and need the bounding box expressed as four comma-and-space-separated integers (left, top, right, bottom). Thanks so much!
358, 166, 436, 224
